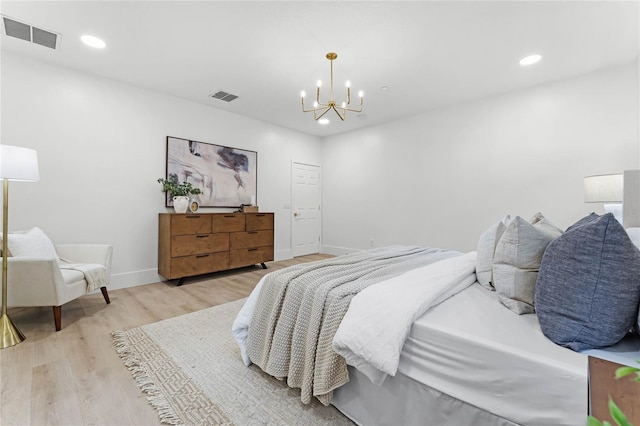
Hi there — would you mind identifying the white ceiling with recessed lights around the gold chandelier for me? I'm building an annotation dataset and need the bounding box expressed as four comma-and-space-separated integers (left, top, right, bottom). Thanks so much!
0, 0, 640, 137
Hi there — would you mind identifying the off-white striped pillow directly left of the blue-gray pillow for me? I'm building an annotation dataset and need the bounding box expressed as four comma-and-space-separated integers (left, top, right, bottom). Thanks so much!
493, 213, 562, 314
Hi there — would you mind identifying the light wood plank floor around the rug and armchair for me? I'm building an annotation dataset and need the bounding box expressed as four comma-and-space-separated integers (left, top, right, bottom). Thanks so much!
0, 255, 329, 426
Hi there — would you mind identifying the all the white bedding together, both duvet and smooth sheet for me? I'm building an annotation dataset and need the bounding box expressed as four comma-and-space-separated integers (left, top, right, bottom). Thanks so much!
233, 248, 638, 425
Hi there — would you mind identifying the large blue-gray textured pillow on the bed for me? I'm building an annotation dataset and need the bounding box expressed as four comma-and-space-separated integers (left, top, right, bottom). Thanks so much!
535, 213, 640, 351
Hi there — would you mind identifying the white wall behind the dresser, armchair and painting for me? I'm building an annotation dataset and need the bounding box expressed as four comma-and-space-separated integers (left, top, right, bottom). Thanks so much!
1, 52, 321, 288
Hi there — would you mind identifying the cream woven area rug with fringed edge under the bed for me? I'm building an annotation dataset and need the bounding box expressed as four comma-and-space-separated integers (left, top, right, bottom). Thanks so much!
112, 299, 353, 426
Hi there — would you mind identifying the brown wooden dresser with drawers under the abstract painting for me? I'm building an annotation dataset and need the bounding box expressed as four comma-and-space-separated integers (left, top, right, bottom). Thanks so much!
158, 213, 273, 285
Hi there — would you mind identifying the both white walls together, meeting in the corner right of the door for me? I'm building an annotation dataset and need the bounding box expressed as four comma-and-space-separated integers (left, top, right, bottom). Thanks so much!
5, 53, 640, 288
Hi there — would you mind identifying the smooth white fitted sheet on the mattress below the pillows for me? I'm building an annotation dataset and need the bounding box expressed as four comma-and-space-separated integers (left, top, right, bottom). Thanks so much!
398, 283, 587, 425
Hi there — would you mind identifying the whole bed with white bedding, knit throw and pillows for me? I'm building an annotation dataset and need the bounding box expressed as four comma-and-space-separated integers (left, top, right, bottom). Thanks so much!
232, 214, 640, 426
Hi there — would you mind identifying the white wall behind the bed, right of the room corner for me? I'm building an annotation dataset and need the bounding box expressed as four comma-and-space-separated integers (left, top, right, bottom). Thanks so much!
322, 64, 640, 254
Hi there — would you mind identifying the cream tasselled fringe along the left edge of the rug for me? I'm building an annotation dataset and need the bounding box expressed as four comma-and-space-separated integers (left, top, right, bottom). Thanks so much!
111, 331, 184, 425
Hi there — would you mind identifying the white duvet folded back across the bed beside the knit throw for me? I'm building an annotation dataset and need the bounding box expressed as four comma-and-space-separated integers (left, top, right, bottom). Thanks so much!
333, 252, 476, 384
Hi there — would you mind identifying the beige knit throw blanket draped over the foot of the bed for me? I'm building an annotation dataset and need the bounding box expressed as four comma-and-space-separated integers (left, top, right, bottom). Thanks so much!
247, 246, 460, 405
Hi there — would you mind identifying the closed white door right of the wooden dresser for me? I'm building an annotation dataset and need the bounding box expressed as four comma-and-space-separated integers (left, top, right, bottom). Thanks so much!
291, 163, 321, 257
